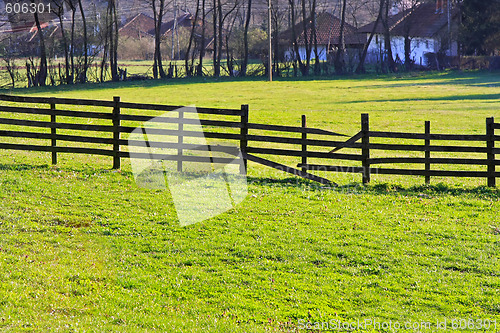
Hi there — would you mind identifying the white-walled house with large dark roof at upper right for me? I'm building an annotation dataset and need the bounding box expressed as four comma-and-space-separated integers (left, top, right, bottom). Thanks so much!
358, 0, 459, 66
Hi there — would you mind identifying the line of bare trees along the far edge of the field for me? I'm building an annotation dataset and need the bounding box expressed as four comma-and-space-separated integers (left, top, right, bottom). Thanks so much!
0, 0, 500, 86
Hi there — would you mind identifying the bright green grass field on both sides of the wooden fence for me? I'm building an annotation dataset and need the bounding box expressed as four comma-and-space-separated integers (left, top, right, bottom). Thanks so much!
0, 72, 500, 332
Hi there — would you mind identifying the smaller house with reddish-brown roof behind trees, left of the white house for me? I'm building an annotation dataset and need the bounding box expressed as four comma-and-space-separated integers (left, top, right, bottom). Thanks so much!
280, 12, 365, 61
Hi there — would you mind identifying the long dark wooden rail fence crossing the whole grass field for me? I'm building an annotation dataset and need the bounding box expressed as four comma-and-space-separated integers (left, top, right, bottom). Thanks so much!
0, 95, 500, 186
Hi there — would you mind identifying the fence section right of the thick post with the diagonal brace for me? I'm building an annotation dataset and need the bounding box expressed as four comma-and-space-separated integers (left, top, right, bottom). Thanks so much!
298, 114, 500, 187
